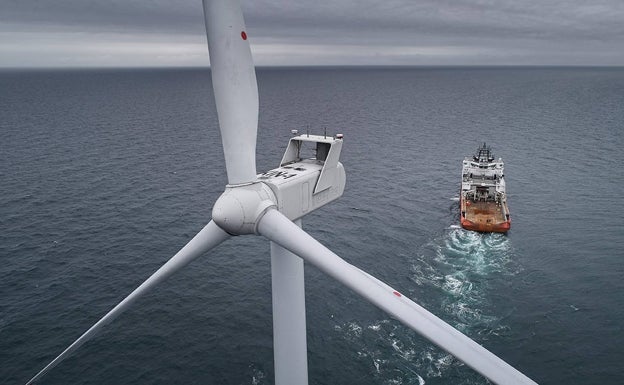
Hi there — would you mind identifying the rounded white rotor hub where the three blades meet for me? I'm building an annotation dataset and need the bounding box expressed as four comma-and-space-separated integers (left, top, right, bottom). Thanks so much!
212, 182, 277, 235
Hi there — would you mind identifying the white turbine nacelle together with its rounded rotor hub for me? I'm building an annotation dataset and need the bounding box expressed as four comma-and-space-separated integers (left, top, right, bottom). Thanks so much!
212, 135, 346, 235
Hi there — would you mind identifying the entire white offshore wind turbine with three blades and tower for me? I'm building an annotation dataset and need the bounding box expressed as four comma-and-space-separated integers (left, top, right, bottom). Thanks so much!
28, 0, 535, 385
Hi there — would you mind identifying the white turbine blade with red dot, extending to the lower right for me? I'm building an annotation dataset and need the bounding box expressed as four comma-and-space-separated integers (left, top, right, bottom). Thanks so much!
258, 210, 536, 385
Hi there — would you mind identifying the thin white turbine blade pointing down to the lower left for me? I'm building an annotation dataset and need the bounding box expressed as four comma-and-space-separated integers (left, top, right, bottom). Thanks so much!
26, 221, 230, 385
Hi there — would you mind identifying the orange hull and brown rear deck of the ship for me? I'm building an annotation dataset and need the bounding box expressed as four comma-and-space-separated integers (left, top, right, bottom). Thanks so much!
460, 196, 511, 233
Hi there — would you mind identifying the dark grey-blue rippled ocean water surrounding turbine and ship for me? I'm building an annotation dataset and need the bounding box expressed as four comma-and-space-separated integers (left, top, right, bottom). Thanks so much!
0, 68, 624, 385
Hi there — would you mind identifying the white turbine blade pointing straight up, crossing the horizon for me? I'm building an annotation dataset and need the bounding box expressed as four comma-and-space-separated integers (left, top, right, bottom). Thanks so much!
203, 0, 258, 185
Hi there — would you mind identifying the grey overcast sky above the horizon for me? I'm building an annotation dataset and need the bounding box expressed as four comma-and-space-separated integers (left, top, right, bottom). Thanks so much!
0, 0, 624, 68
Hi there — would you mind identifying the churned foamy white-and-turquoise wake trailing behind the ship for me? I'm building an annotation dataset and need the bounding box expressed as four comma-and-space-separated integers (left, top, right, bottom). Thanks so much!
334, 228, 518, 385
